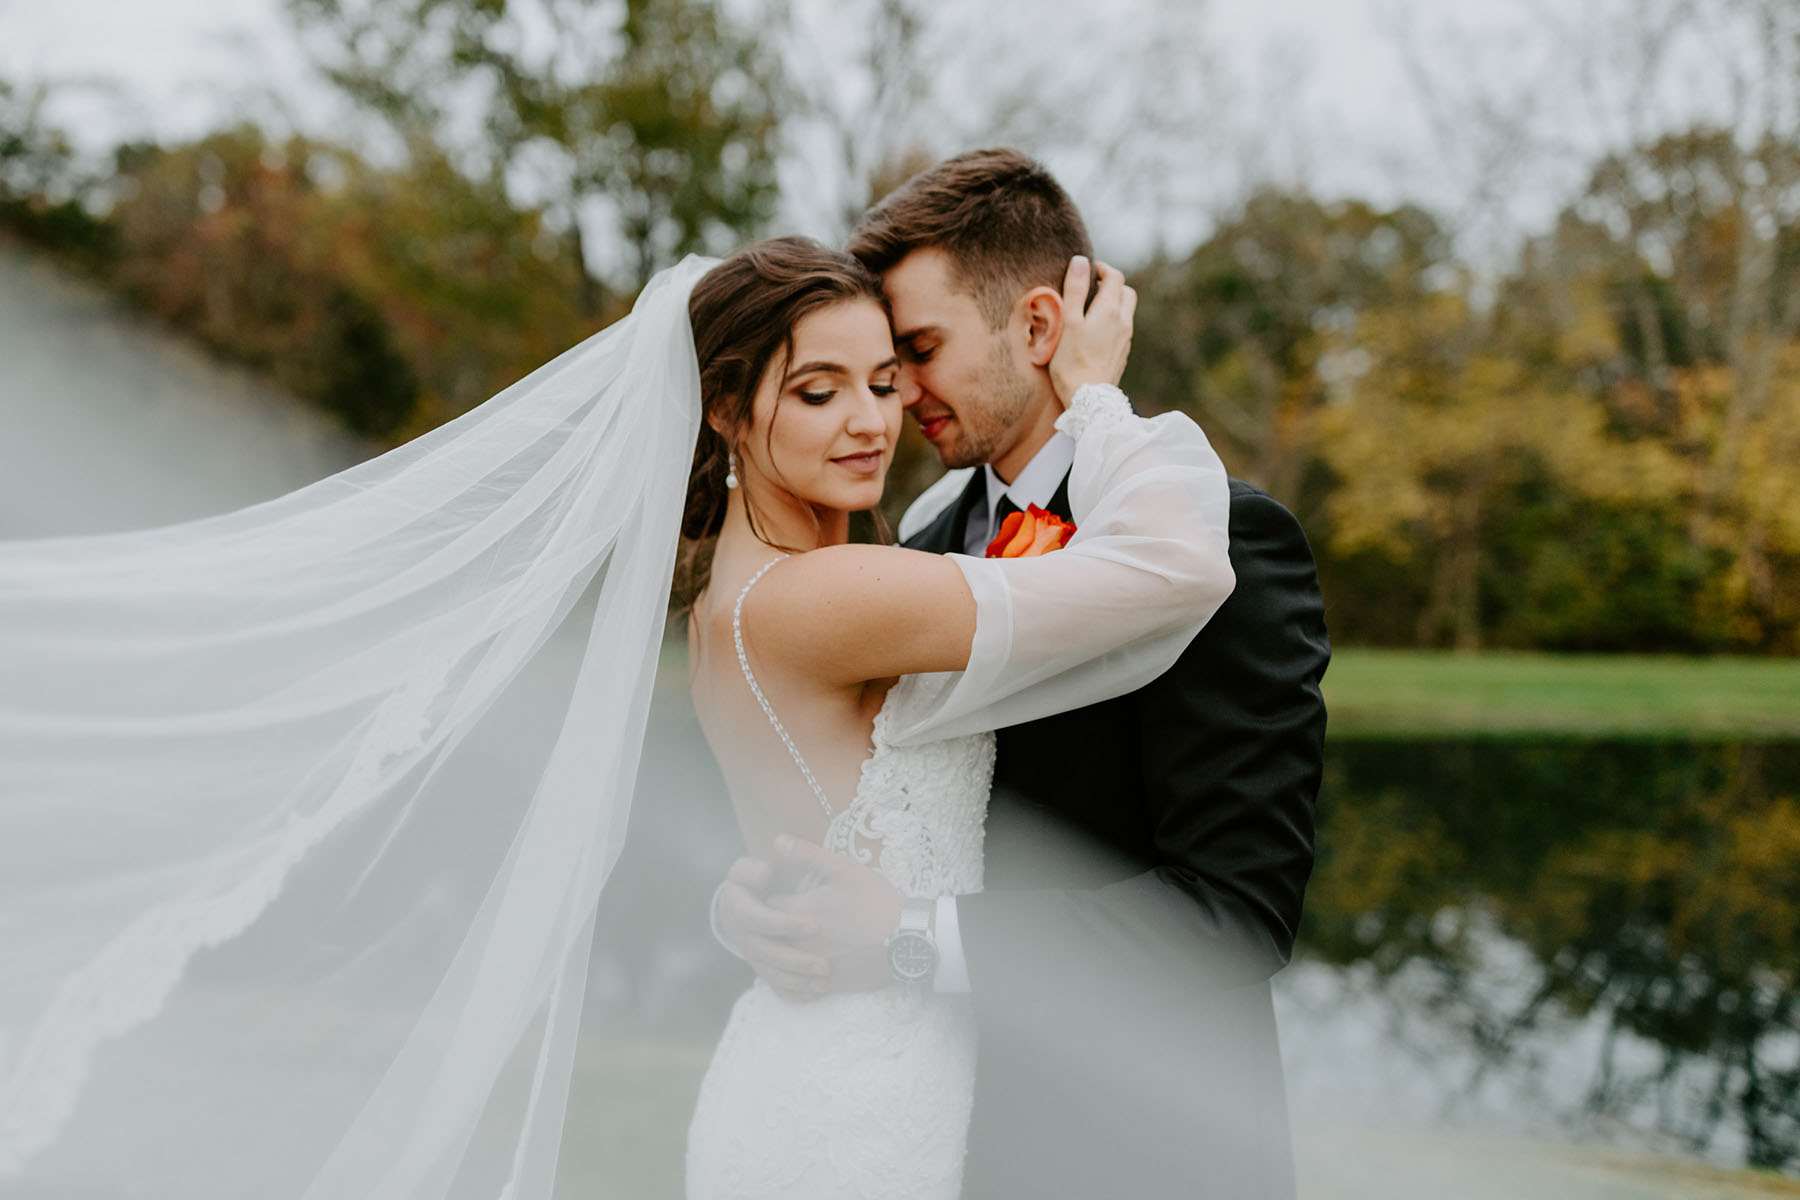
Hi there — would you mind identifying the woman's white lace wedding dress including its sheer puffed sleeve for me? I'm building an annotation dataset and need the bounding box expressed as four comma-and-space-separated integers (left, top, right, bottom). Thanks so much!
688, 389, 1229, 1200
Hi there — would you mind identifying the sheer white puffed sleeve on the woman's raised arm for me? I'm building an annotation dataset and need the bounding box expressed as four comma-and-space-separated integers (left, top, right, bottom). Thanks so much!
889, 385, 1233, 743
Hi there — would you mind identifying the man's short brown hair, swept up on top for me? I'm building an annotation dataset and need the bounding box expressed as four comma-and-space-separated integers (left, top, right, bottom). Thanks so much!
848, 149, 1094, 329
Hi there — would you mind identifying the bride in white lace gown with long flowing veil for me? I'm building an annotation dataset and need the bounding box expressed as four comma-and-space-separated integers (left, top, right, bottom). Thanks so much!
0, 230, 1231, 1200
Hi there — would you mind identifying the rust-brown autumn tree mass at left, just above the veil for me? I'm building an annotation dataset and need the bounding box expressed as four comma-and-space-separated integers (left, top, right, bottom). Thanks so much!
94, 126, 592, 441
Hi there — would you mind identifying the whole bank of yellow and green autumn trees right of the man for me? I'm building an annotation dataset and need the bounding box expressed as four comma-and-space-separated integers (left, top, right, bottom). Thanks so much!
1125, 150, 1800, 655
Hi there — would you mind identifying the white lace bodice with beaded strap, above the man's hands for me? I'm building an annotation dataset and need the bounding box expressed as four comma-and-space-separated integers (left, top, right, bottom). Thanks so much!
731, 554, 994, 896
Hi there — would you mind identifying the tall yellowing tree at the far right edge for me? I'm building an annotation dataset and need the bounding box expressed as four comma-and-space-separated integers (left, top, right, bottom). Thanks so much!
1501, 128, 1800, 649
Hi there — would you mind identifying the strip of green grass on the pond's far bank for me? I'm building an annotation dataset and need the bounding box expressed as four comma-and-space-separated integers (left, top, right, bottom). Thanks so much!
1325, 649, 1800, 738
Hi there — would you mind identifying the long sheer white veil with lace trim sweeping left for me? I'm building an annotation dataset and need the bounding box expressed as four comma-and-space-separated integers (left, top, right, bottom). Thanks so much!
0, 257, 713, 1200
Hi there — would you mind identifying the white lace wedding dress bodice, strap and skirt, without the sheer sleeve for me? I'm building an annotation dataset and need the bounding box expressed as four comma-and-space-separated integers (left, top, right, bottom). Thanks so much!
688, 560, 994, 1200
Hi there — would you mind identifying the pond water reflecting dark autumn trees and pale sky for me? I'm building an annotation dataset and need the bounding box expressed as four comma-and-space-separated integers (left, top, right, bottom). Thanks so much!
1292, 741, 1800, 1169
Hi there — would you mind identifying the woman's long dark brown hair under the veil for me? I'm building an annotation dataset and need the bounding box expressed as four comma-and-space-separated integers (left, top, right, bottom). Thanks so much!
675, 237, 886, 608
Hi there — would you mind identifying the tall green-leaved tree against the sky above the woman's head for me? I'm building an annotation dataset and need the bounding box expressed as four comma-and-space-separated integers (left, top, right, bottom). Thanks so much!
288, 0, 785, 305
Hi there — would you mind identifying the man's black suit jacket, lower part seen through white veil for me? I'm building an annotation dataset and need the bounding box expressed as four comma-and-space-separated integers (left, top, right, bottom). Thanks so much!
907, 471, 1330, 1200
